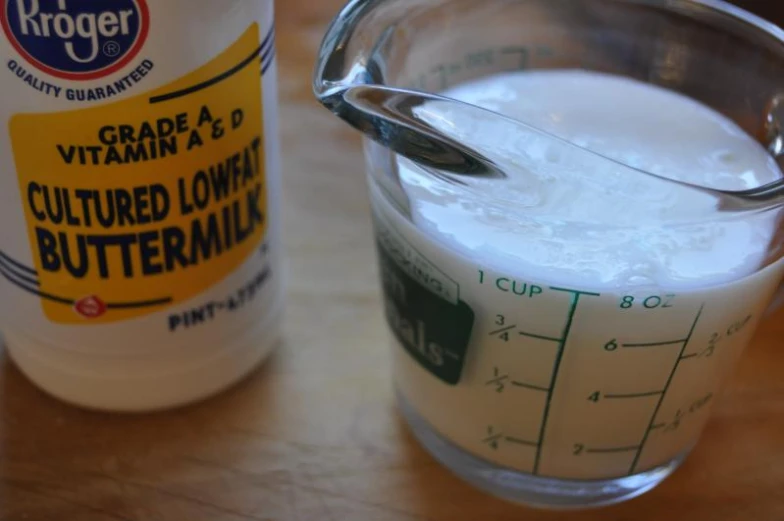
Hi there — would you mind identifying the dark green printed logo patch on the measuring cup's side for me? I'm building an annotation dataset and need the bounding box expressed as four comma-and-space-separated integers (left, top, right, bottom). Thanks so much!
377, 221, 474, 385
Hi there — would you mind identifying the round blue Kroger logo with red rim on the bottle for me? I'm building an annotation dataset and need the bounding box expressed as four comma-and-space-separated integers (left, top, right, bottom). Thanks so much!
0, 0, 150, 80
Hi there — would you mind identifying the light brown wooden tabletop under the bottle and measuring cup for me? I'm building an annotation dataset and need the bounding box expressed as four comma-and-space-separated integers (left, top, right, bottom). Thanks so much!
0, 0, 784, 521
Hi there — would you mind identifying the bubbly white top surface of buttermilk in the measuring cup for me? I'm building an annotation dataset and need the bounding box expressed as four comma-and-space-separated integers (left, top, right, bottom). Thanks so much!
401, 71, 782, 289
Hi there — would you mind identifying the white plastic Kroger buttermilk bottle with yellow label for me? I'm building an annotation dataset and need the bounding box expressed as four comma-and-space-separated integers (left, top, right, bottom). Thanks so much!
0, 0, 283, 411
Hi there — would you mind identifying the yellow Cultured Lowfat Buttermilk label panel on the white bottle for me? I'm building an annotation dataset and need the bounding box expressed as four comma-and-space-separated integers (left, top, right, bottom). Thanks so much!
10, 24, 268, 324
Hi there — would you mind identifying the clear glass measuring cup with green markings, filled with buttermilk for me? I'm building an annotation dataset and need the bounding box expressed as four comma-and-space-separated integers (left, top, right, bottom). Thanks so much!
316, 0, 784, 507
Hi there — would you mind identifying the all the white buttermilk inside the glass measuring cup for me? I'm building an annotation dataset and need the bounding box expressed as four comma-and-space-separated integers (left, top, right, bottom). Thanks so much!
372, 71, 784, 479
